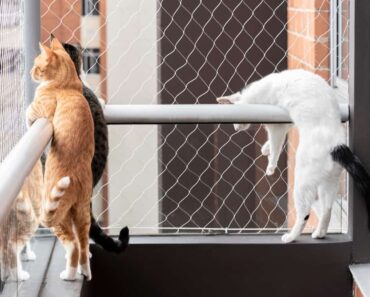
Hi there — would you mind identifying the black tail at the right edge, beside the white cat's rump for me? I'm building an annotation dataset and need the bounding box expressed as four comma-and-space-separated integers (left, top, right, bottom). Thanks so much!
331, 144, 370, 229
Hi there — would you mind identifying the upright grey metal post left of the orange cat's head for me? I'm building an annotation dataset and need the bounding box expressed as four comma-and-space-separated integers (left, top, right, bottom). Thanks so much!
23, 0, 40, 105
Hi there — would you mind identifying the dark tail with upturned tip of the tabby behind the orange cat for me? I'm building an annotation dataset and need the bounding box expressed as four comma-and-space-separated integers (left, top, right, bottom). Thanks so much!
90, 216, 130, 253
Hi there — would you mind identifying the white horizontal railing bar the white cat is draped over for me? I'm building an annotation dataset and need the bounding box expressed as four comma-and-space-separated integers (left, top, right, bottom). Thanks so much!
104, 104, 349, 124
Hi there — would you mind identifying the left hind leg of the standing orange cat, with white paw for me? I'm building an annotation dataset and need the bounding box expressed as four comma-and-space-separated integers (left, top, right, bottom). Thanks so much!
54, 213, 79, 281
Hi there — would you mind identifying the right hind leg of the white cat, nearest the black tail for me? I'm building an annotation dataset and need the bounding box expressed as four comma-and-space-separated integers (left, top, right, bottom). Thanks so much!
312, 176, 339, 238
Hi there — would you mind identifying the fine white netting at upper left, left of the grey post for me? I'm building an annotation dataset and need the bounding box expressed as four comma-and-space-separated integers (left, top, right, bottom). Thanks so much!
0, 0, 25, 160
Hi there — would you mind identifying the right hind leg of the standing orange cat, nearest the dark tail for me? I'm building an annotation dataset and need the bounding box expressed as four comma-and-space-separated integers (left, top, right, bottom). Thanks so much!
73, 203, 91, 280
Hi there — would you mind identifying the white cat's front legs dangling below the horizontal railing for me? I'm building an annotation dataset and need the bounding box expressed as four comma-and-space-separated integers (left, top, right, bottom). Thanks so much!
261, 124, 292, 175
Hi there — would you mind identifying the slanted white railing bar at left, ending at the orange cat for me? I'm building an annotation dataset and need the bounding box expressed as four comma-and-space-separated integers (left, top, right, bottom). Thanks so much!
0, 119, 53, 223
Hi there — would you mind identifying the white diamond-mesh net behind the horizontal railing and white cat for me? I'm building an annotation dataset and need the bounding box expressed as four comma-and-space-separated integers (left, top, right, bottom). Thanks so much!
41, 0, 349, 233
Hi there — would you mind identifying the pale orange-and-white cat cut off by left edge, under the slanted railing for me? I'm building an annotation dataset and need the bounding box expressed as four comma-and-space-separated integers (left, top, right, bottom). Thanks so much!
0, 161, 42, 281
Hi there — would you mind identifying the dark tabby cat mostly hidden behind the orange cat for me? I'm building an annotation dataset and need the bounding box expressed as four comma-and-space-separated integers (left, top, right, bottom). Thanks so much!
63, 43, 129, 253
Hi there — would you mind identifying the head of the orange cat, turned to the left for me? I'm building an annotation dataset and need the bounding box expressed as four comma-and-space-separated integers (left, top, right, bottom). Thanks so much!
31, 38, 77, 81
